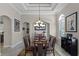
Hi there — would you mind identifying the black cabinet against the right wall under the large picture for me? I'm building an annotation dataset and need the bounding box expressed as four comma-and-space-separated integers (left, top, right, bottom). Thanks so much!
61, 37, 78, 56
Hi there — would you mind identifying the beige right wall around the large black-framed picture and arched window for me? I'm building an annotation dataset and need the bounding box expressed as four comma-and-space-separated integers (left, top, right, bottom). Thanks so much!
56, 3, 79, 53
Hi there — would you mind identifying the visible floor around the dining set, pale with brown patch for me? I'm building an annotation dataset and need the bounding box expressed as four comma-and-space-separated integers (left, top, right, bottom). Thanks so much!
1, 44, 60, 56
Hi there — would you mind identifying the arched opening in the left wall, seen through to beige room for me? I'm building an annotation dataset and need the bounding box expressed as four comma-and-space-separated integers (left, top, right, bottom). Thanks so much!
0, 15, 12, 47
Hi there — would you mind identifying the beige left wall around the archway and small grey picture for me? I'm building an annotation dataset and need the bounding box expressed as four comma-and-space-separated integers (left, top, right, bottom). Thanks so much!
0, 3, 22, 47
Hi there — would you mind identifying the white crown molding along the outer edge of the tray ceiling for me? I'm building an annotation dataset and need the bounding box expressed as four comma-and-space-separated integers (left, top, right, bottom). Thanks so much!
10, 3, 67, 15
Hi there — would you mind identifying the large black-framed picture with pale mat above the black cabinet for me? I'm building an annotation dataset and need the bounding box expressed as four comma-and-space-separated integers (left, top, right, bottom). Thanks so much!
65, 12, 77, 32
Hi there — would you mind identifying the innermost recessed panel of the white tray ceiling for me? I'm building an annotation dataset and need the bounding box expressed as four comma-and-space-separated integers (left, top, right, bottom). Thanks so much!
24, 3, 56, 11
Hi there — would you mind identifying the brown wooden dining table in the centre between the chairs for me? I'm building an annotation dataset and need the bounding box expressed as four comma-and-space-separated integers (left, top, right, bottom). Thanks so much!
32, 35, 49, 56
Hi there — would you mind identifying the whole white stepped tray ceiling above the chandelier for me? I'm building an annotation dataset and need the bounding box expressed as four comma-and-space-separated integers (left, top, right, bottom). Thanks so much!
10, 3, 67, 14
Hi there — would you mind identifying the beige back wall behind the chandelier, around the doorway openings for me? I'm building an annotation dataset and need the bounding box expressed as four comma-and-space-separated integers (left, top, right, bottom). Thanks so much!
22, 15, 56, 41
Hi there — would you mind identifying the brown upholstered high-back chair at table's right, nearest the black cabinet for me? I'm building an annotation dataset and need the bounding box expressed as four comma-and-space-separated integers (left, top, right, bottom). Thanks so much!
47, 36, 56, 56
